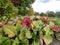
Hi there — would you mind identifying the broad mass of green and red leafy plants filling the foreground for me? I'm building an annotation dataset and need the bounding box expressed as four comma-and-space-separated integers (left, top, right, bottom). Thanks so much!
0, 16, 60, 45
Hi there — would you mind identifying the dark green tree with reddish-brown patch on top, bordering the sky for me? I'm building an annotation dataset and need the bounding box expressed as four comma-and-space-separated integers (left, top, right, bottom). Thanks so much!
12, 0, 35, 15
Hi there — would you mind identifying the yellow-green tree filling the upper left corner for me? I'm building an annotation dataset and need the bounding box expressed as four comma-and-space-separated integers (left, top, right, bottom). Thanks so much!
0, 0, 18, 20
